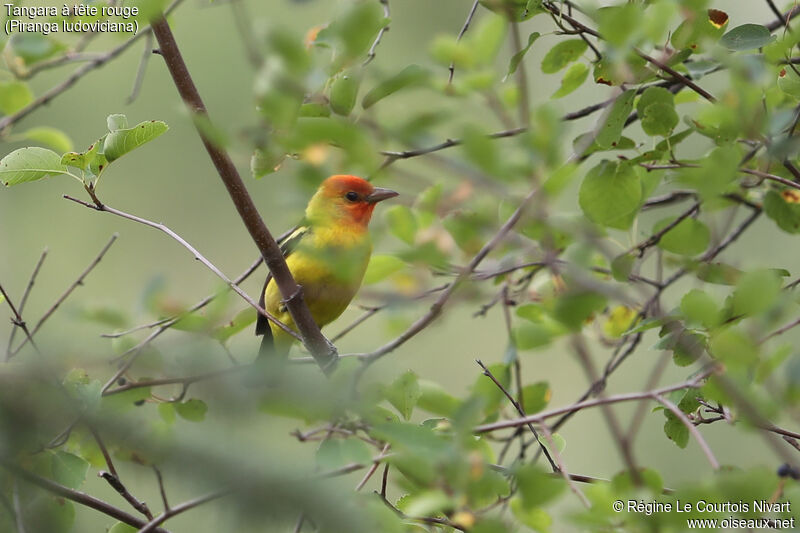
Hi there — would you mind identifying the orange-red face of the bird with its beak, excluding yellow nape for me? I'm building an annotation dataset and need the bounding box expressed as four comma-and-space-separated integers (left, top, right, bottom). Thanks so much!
320, 175, 397, 227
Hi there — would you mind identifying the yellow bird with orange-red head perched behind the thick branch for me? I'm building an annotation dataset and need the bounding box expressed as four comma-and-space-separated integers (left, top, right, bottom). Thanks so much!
256, 174, 398, 360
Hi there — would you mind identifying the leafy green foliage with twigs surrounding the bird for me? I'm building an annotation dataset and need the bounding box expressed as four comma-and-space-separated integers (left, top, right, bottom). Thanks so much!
0, 0, 800, 533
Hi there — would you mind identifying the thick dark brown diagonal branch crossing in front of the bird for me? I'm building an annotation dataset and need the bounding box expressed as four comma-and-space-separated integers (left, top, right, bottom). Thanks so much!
152, 18, 338, 373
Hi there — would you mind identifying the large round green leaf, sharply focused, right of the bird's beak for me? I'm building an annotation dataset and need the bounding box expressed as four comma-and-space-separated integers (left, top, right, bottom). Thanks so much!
578, 160, 642, 229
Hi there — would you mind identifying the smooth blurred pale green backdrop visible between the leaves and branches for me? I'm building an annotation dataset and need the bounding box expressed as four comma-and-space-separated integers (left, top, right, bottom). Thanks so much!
0, 0, 797, 532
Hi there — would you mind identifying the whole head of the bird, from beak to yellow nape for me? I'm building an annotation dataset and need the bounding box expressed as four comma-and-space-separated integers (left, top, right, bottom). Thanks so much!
306, 174, 397, 228
